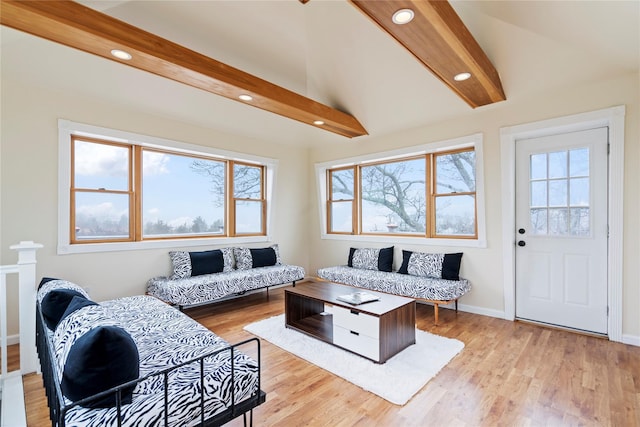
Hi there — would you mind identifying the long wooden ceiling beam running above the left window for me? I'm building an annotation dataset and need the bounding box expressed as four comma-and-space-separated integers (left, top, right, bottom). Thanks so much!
0, 0, 367, 138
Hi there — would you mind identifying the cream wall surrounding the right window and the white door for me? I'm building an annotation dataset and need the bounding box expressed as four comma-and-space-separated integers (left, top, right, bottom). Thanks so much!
308, 73, 640, 345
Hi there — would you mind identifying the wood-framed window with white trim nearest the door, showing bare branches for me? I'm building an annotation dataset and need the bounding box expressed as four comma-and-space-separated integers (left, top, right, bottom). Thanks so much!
316, 135, 484, 245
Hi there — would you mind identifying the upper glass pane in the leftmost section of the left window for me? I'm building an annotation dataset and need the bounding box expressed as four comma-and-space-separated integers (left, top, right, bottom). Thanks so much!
73, 140, 130, 191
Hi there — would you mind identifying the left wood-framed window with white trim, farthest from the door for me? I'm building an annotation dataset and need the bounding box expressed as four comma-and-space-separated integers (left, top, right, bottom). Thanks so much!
59, 120, 277, 253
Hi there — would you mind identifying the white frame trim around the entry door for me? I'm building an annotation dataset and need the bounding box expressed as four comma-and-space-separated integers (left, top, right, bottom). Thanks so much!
500, 105, 625, 342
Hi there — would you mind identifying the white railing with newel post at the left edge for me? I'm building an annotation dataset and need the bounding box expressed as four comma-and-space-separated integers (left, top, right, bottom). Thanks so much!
0, 242, 42, 426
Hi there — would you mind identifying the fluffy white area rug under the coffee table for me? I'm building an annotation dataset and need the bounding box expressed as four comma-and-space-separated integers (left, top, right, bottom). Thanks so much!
244, 314, 464, 405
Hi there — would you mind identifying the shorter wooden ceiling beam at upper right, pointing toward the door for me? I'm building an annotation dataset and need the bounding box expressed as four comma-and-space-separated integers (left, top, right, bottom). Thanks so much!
349, 0, 506, 108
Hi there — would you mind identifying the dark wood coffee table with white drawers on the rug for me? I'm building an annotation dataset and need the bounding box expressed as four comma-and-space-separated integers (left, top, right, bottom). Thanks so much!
284, 282, 416, 363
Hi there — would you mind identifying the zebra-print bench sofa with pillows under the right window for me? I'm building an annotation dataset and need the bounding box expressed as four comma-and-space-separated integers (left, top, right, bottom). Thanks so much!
318, 247, 471, 325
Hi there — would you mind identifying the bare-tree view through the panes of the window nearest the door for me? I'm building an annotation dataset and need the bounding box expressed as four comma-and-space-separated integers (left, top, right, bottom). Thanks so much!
328, 150, 476, 237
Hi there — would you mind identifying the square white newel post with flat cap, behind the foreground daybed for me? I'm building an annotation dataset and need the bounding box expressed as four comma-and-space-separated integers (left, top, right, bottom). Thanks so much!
9, 241, 43, 375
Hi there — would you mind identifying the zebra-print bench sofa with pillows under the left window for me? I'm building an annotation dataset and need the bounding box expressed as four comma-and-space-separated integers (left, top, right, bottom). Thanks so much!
147, 245, 305, 309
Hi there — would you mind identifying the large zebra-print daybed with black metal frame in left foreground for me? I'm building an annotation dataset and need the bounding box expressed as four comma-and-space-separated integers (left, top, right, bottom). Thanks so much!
36, 279, 265, 427
